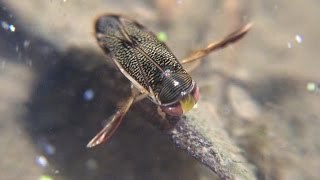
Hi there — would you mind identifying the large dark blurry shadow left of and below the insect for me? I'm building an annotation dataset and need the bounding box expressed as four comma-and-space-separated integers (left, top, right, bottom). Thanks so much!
24, 44, 208, 179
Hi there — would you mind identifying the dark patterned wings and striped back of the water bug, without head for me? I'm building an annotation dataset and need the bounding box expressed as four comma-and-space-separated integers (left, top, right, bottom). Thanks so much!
96, 15, 192, 104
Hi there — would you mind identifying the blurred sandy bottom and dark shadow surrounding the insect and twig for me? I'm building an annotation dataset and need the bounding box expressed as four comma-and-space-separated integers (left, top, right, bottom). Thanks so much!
0, 0, 320, 180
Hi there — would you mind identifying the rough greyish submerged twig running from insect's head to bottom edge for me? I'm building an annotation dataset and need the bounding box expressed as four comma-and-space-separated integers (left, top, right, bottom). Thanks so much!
161, 103, 256, 179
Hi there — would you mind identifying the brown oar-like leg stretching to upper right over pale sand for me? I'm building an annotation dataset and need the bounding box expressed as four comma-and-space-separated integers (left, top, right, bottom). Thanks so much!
180, 23, 252, 64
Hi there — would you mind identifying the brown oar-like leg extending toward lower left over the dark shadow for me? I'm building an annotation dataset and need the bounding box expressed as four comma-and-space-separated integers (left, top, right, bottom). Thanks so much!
87, 88, 141, 148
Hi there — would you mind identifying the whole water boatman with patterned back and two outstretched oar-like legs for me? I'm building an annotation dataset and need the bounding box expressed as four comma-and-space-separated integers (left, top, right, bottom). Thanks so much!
87, 14, 251, 147
